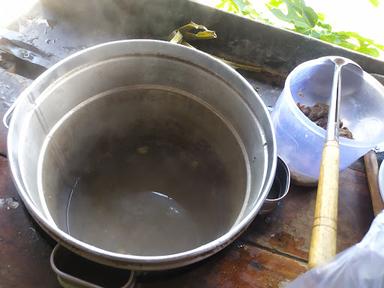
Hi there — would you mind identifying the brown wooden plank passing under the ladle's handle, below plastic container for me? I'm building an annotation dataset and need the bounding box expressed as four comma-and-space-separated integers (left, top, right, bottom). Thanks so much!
243, 169, 373, 260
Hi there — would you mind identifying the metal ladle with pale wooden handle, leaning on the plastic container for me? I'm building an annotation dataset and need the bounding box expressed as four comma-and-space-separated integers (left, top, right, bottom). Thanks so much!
308, 57, 362, 268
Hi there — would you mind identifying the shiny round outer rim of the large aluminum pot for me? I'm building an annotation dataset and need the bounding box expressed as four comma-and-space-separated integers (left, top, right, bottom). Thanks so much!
7, 39, 277, 270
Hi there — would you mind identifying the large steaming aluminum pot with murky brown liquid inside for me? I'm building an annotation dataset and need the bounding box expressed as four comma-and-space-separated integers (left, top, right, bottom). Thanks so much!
8, 40, 276, 270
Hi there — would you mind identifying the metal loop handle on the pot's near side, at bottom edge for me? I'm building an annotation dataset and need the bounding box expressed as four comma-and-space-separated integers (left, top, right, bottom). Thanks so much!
50, 244, 136, 288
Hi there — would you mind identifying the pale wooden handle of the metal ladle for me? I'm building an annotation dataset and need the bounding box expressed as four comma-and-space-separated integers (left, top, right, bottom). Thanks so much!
308, 141, 339, 268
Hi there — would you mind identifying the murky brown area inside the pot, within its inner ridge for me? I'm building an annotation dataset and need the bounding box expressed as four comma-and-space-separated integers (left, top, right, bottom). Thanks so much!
43, 90, 247, 256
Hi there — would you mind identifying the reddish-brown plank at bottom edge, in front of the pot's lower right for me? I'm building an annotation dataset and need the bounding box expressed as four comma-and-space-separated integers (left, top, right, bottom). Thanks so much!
138, 242, 306, 288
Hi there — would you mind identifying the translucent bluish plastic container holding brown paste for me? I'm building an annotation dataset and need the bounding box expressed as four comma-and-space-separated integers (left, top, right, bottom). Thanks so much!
272, 57, 384, 185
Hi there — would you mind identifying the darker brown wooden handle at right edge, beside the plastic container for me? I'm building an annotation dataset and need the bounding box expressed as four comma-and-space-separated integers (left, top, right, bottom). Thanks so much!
364, 150, 384, 216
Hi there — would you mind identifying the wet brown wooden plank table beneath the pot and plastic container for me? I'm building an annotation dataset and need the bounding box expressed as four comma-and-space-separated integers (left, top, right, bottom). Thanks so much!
0, 1, 373, 288
